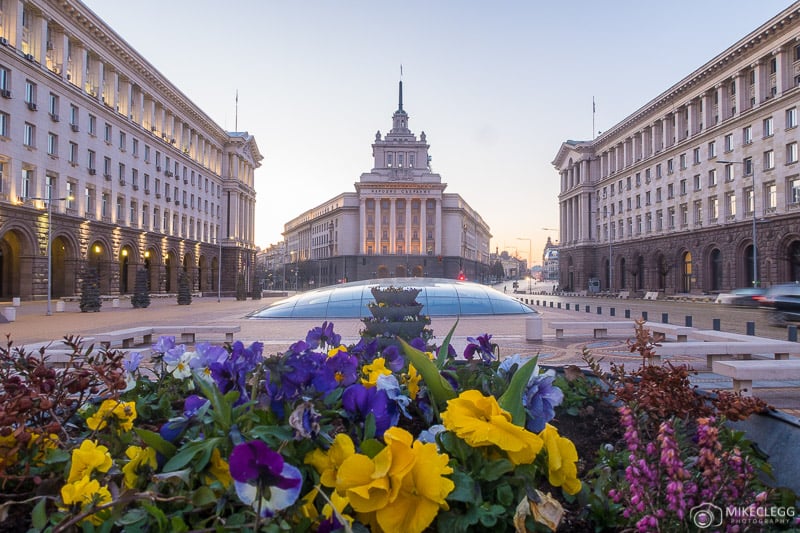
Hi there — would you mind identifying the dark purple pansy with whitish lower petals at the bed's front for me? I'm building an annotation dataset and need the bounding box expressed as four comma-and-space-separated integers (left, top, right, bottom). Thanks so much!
228, 440, 303, 517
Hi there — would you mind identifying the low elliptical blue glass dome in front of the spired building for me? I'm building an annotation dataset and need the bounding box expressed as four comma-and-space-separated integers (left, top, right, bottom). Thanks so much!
250, 278, 536, 319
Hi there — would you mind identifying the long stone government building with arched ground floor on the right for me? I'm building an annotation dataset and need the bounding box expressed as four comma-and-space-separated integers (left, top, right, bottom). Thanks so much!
553, 2, 800, 293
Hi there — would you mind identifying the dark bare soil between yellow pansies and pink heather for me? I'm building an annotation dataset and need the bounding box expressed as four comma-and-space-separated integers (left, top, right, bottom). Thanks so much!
552, 401, 624, 533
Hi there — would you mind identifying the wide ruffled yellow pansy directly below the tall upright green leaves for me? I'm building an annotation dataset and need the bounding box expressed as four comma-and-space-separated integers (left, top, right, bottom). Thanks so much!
442, 390, 544, 464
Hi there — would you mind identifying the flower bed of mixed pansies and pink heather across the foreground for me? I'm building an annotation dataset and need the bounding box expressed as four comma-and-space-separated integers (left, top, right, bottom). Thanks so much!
0, 323, 796, 532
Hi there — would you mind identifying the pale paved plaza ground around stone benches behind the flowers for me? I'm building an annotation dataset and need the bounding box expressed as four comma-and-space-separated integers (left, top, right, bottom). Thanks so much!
0, 297, 800, 417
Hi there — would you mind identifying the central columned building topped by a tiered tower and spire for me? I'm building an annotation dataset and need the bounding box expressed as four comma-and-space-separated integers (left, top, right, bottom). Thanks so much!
283, 81, 491, 288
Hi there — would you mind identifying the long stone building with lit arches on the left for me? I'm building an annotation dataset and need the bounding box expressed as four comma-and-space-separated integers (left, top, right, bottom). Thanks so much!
0, 0, 262, 299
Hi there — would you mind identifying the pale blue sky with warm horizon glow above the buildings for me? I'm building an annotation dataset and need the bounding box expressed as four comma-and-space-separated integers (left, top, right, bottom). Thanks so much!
85, 0, 791, 264
